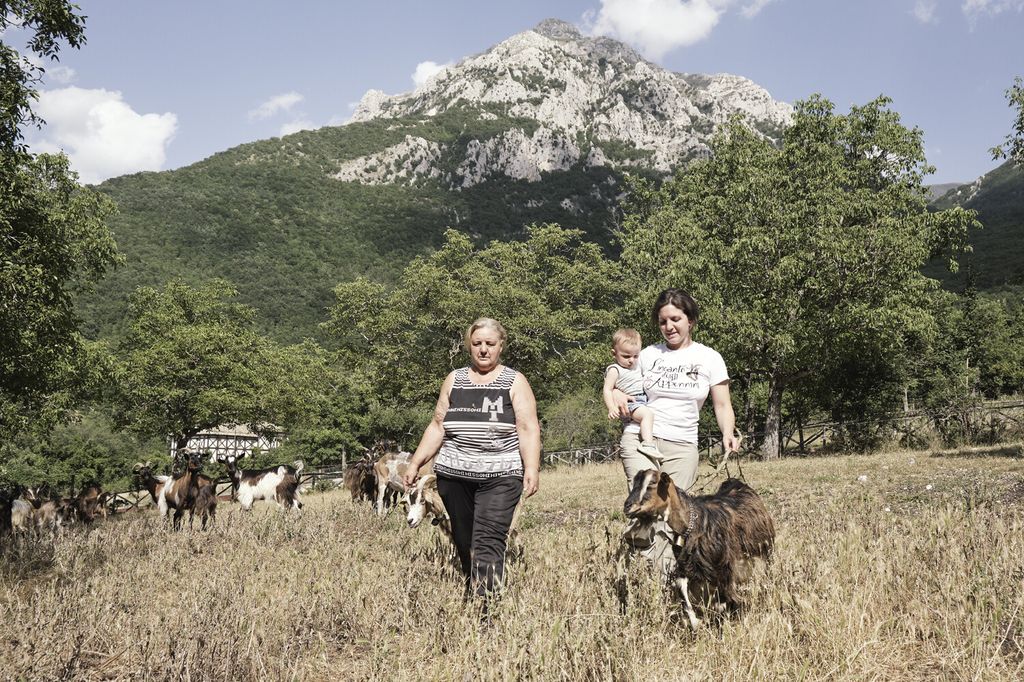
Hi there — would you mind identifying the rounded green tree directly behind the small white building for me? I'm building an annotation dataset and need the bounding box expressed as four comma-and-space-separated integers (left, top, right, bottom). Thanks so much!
116, 280, 324, 454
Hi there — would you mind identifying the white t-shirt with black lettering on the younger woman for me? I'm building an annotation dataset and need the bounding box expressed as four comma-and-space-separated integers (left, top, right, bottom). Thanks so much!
626, 341, 729, 442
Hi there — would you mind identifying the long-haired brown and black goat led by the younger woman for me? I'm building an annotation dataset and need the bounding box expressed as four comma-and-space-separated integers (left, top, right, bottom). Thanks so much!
624, 469, 775, 628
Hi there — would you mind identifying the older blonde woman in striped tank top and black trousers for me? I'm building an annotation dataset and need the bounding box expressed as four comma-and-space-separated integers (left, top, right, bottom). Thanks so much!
404, 317, 541, 596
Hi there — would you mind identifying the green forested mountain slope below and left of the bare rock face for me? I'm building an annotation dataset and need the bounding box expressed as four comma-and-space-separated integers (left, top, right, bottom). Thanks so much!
82, 109, 621, 341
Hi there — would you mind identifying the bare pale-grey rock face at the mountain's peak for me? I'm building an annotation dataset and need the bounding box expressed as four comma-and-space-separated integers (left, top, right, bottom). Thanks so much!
335, 19, 793, 188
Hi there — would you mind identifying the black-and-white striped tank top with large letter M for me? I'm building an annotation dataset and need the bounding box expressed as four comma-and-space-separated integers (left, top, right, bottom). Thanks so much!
434, 367, 522, 480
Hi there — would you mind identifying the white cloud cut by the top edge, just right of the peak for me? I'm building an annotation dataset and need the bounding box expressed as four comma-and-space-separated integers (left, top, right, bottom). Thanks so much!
583, 0, 774, 60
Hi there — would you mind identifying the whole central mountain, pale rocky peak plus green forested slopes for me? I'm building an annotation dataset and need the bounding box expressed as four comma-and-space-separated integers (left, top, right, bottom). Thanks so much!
80, 20, 793, 341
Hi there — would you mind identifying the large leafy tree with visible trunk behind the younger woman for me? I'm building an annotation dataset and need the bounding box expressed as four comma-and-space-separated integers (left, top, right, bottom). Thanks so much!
623, 96, 973, 458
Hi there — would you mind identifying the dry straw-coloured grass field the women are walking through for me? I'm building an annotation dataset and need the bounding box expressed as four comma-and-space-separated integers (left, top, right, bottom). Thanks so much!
0, 445, 1024, 680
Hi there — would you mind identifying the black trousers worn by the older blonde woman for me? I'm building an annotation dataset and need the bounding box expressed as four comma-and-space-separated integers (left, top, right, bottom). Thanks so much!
437, 475, 522, 597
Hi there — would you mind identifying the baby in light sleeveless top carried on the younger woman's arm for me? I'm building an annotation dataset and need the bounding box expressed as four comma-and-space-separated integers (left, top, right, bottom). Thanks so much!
602, 329, 664, 462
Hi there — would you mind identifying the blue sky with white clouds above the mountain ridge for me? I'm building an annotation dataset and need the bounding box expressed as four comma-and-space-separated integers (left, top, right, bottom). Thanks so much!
14, 0, 1024, 182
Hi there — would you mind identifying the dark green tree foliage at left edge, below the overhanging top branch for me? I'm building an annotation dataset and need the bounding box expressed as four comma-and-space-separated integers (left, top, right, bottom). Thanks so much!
0, 155, 118, 440
